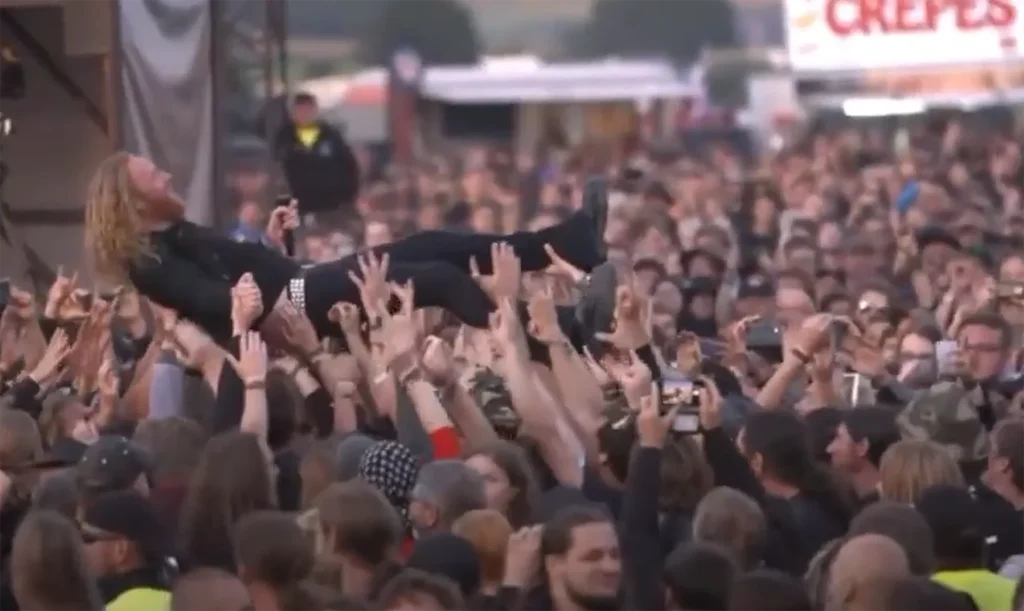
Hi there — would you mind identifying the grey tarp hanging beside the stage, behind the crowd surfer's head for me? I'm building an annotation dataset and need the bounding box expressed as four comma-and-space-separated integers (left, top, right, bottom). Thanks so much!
118, 0, 215, 224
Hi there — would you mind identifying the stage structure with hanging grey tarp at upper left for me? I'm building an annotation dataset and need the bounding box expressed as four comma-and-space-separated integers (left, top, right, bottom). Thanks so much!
0, 0, 287, 289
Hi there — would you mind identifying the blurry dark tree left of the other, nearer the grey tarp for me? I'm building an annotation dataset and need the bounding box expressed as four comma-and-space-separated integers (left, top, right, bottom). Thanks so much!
362, 0, 480, 66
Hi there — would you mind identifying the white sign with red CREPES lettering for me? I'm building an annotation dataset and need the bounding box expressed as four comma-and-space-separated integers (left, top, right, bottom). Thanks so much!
785, 0, 1024, 72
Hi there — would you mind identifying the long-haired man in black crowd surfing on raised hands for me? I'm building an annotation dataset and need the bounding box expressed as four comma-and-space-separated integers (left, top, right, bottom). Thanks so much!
86, 152, 607, 350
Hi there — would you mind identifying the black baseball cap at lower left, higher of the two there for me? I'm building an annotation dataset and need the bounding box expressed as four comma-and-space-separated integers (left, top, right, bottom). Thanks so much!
77, 435, 151, 494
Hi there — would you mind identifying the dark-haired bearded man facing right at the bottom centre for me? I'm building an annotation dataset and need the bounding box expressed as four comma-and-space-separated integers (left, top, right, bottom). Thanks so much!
524, 506, 622, 611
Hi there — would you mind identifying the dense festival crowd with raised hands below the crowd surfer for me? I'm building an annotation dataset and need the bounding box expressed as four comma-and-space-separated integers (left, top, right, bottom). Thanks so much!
0, 94, 1024, 611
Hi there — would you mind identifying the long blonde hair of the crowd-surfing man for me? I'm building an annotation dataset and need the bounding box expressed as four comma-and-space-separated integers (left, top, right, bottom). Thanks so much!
85, 150, 150, 280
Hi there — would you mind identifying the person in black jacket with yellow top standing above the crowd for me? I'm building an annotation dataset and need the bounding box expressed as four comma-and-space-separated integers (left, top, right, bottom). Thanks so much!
273, 92, 361, 226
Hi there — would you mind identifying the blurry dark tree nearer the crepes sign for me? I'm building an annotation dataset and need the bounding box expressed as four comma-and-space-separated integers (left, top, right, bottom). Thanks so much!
582, 0, 736, 63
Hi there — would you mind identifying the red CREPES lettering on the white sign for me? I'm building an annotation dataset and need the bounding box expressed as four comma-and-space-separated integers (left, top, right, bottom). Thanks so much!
825, 0, 1018, 36
